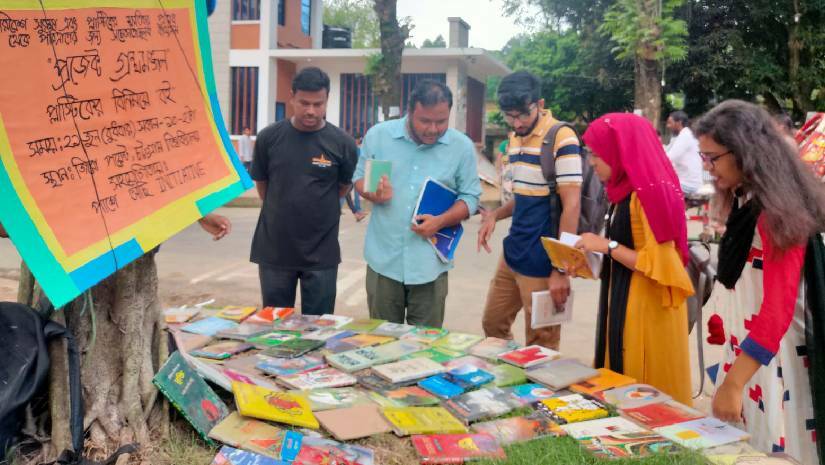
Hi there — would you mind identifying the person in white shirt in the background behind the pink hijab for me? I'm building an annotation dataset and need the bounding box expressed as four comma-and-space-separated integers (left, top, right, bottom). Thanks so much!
665, 111, 702, 194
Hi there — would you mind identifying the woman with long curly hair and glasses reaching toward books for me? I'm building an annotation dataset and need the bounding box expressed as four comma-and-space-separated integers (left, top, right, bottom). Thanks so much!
695, 100, 825, 464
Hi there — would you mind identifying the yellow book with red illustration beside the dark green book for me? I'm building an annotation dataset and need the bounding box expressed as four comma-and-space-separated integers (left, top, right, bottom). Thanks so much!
232, 381, 320, 429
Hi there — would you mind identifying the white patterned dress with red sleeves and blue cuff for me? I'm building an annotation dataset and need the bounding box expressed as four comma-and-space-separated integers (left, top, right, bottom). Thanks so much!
708, 219, 819, 465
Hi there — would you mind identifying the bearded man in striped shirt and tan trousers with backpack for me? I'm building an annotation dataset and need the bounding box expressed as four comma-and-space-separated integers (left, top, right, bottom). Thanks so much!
478, 71, 582, 349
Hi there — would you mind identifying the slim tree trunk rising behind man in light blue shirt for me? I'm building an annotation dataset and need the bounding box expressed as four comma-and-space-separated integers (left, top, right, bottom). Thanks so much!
373, 0, 410, 120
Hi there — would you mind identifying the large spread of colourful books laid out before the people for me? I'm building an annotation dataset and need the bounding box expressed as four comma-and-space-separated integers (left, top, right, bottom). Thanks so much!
154, 307, 793, 465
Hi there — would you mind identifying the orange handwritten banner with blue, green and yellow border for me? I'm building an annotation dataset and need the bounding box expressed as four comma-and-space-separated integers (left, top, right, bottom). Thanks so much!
0, 0, 252, 306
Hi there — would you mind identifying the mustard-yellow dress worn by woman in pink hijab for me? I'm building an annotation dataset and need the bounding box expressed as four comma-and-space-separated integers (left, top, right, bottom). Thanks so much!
605, 193, 693, 405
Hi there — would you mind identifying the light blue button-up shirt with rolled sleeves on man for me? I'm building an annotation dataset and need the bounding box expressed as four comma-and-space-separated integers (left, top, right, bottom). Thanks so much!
353, 117, 481, 284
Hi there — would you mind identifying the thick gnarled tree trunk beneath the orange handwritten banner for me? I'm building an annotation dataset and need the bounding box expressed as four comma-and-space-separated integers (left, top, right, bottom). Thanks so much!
43, 253, 168, 463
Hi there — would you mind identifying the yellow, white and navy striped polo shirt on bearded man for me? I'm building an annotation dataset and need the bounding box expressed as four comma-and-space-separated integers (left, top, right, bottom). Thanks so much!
504, 110, 582, 277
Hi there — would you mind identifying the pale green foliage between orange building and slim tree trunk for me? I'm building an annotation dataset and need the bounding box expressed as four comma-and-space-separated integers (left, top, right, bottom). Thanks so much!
324, 0, 381, 48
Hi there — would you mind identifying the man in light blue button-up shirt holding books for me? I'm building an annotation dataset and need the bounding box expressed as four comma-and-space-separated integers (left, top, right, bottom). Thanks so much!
353, 80, 481, 328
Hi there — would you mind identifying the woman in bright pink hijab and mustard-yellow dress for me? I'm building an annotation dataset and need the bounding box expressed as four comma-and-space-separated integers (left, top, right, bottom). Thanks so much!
577, 113, 693, 405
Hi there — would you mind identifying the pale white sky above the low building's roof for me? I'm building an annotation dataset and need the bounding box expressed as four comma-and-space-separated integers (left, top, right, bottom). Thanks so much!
397, 0, 536, 50
